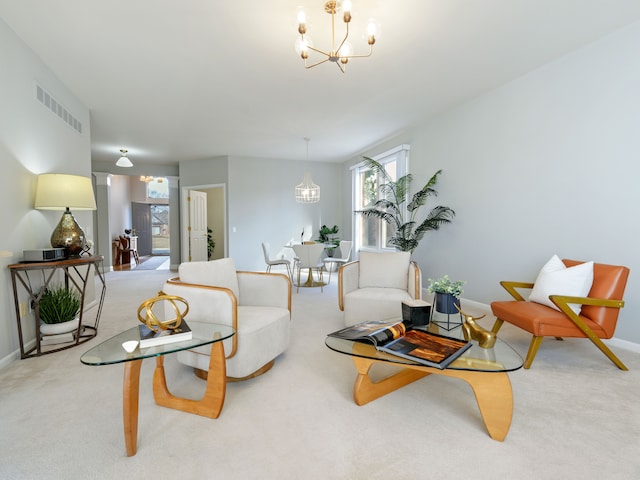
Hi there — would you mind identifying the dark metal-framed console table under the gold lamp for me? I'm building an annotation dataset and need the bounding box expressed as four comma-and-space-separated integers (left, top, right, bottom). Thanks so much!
8, 256, 107, 359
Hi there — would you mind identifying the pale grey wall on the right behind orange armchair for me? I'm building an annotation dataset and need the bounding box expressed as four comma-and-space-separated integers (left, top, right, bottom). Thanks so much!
352, 19, 640, 344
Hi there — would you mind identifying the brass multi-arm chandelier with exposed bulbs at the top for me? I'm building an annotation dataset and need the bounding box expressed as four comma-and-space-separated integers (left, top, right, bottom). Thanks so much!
296, 0, 377, 73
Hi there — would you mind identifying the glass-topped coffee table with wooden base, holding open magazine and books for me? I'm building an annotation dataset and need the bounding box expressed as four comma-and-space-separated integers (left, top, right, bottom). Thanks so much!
325, 324, 523, 441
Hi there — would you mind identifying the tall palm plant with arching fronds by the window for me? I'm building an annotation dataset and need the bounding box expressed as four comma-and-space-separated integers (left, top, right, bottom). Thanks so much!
355, 157, 456, 252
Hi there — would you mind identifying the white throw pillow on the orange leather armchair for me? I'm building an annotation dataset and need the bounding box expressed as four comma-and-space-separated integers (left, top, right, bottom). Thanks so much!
529, 255, 593, 314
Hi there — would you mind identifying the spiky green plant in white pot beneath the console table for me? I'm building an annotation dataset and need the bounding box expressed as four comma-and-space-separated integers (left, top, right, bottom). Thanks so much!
38, 285, 81, 335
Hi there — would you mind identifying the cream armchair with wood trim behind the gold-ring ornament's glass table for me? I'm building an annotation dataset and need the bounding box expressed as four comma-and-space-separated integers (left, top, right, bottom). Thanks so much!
163, 258, 291, 380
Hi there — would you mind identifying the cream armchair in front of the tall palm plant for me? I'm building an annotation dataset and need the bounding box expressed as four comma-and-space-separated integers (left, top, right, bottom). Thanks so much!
338, 252, 422, 326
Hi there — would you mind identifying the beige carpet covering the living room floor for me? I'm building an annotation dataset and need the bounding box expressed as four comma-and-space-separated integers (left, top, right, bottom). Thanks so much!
0, 270, 640, 480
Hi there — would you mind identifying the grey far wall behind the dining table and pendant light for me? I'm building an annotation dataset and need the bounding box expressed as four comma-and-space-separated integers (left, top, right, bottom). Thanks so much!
180, 157, 343, 270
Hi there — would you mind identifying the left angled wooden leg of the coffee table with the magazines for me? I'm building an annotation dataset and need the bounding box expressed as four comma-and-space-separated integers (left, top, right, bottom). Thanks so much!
353, 357, 431, 405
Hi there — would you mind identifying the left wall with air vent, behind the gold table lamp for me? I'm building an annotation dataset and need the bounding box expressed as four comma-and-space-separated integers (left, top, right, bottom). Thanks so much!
0, 20, 94, 366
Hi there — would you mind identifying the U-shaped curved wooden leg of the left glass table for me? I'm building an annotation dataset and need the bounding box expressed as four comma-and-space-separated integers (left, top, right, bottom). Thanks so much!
153, 341, 227, 418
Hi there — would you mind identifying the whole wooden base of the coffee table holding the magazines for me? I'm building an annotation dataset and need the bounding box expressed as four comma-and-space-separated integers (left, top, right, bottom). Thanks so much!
352, 356, 513, 442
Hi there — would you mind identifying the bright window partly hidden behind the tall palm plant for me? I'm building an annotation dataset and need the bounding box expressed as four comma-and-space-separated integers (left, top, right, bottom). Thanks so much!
352, 145, 409, 251
